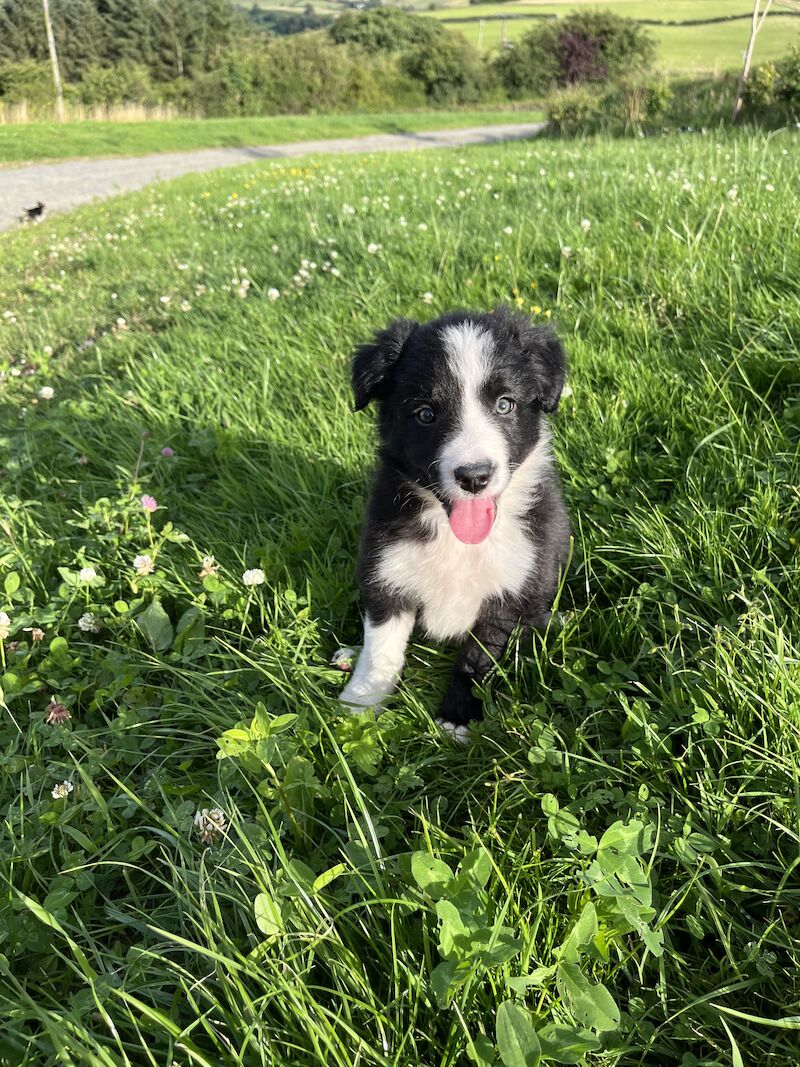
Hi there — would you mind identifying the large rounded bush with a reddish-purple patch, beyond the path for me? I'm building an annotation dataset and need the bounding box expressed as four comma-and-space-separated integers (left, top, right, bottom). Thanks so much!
495, 12, 655, 97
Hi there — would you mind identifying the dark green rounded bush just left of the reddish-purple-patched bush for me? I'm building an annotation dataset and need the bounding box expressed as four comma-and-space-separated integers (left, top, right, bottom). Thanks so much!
401, 33, 493, 103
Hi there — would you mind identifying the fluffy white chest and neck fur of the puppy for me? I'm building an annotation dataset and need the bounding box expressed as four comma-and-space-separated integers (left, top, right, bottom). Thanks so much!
375, 433, 549, 640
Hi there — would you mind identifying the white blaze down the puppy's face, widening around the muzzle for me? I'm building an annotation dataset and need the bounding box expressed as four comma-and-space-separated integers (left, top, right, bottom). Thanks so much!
439, 322, 509, 496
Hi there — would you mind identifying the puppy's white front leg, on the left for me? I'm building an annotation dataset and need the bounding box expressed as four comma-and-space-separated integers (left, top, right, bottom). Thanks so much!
339, 608, 416, 711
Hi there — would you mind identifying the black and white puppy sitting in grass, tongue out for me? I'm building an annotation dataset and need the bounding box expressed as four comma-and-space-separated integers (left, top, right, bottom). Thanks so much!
340, 307, 570, 737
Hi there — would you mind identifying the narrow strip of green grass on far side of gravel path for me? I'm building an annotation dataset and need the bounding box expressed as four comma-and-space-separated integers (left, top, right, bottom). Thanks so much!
0, 109, 544, 163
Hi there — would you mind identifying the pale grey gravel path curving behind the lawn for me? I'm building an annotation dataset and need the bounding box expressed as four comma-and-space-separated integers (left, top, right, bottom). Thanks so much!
0, 123, 545, 230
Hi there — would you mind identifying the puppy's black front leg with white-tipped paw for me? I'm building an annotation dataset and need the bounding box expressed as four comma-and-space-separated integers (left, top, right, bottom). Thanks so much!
436, 605, 519, 740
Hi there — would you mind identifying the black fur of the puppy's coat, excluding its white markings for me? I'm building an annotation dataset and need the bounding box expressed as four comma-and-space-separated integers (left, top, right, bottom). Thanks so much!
353, 307, 570, 724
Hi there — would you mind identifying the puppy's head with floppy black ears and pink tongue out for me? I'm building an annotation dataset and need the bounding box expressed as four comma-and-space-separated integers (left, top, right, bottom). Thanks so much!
353, 307, 564, 543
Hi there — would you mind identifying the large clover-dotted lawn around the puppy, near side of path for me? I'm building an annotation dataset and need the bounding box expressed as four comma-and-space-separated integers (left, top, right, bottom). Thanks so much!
0, 132, 800, 1067
